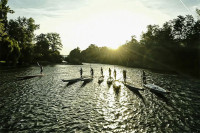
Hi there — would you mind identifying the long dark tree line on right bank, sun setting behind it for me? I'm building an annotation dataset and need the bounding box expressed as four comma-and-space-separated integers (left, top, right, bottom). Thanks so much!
65, 9, 200, 77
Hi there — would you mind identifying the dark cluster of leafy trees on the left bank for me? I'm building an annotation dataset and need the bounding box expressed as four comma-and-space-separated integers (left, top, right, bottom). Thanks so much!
0, 0, 62, 65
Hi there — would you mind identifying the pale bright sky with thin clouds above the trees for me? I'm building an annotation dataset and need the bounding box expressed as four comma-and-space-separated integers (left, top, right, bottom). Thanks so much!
8, 0, 200, 55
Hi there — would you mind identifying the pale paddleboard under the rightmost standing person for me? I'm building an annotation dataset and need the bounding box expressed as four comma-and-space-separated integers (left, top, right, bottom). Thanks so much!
144, 84, 170, 94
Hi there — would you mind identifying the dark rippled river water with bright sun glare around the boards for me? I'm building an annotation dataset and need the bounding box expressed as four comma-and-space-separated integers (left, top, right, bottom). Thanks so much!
0, 64, 200, 133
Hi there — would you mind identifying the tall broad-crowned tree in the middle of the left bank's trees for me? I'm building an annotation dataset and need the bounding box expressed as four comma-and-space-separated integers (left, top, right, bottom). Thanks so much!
8, 17, 39, 64
